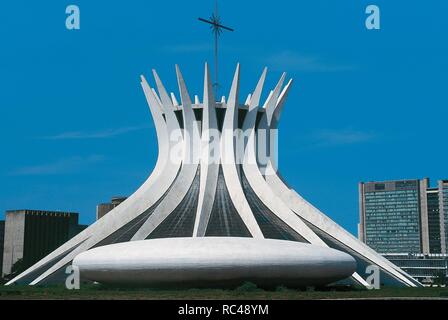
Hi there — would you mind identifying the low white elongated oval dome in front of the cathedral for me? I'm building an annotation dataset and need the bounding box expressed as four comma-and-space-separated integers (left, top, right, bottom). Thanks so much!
73, 237, 356, 287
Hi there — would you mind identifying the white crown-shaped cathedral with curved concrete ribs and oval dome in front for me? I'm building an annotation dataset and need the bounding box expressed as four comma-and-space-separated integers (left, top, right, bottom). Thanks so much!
8, 65, 420, 287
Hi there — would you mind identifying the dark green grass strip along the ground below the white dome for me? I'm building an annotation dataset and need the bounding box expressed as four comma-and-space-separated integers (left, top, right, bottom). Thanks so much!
0, 286, 448, 300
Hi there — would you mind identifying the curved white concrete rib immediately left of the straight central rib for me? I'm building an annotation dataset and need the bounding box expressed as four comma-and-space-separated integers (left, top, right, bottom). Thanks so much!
131, 65, 200, 241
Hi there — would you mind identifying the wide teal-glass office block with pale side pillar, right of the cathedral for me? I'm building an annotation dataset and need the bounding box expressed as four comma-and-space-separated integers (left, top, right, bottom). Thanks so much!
359, 180, 428, 253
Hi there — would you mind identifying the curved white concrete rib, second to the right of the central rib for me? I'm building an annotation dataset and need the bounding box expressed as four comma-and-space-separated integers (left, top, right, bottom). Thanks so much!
243, 69, 327, 247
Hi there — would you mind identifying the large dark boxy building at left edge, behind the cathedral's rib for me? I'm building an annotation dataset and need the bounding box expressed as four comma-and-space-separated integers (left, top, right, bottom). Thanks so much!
2, 210, 86, 276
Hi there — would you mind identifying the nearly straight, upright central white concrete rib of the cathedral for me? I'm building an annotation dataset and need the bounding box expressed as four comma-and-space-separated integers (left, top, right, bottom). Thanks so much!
193, 63, 219, 237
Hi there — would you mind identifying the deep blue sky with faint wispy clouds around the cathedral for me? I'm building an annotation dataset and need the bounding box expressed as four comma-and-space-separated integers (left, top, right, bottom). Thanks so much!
0, 0, 448, 233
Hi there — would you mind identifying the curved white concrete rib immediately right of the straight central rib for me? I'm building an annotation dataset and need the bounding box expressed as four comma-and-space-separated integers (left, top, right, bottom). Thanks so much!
221, 64, 264, 238
